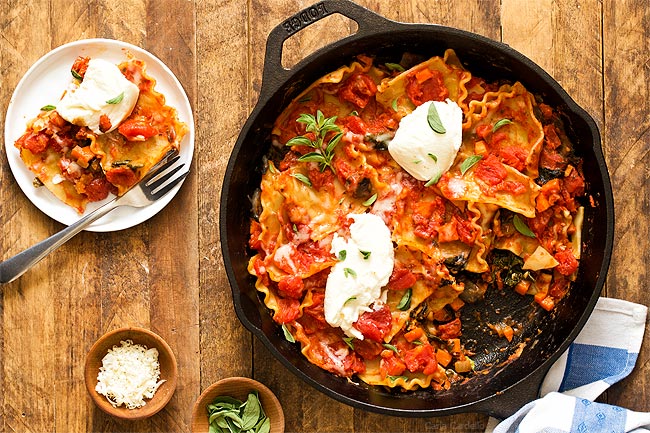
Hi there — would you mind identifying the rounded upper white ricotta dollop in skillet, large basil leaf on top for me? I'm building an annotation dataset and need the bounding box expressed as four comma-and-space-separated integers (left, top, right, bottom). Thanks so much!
388, 99, 463, 181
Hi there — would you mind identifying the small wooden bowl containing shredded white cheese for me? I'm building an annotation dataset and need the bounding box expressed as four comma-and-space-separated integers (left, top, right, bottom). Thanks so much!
84, 327, 178, 421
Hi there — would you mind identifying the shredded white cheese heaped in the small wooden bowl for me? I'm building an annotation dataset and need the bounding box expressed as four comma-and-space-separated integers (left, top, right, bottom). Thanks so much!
95, 340, 165, 409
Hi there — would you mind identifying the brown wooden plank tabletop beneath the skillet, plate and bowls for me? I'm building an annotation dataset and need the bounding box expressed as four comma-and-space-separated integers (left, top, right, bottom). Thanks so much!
0, 0, 650, 433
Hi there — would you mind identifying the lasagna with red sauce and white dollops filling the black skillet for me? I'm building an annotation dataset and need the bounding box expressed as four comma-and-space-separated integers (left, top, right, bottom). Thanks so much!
248, 50, 585, 390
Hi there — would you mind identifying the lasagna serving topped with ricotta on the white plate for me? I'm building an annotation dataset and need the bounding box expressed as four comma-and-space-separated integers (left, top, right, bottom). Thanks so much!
15, 57, 188, 213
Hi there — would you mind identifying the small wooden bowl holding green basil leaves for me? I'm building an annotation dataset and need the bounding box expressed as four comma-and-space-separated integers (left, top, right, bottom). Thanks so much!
192, 377, 284, 433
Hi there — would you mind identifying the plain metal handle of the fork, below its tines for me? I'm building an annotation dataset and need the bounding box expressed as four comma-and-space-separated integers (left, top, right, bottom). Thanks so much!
0, 199, 120, 284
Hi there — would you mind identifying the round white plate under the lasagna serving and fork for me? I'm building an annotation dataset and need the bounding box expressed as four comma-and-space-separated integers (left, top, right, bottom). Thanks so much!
5, 39, 194, 232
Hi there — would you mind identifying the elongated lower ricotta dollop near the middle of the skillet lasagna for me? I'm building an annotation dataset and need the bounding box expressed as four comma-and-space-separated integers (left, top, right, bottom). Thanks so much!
324, 213, 395, 340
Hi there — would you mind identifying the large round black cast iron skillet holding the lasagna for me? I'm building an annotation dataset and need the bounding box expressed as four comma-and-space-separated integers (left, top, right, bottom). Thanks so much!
220, 0, 614, 418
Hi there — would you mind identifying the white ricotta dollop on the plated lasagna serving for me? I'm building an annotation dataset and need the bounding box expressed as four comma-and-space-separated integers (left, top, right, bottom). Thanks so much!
56, 59, 140, 134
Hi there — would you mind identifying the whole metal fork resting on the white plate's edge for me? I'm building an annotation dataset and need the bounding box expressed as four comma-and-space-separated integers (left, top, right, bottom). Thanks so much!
0, 151, 189, 284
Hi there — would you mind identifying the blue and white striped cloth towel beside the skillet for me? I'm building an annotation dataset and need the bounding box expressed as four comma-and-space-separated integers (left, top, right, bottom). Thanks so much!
486, 298, 650, 433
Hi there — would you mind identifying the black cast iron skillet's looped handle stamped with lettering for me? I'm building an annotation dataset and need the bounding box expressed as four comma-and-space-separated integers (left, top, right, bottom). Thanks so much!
260, 0, 399, 95
